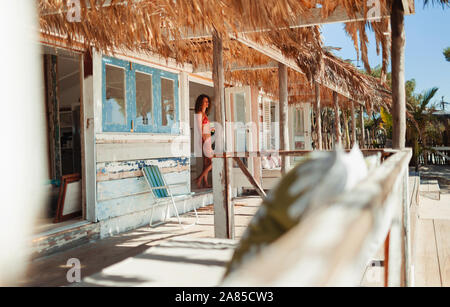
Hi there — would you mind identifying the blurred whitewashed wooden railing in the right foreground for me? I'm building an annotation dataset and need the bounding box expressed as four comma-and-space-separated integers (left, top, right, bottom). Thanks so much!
224, 149, 412, 286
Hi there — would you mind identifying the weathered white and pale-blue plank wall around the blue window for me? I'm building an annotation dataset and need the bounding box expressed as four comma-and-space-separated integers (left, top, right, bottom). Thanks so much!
89, 50, 198, 237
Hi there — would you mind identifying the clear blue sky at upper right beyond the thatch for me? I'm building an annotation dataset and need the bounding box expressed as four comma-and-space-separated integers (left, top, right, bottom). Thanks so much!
322, 4, 450, 110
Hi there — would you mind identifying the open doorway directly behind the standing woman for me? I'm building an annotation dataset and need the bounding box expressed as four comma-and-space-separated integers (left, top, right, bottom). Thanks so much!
189, 81, 215, 193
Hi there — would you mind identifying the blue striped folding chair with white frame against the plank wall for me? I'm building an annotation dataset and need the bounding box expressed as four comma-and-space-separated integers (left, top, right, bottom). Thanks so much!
142, 165, 198, 228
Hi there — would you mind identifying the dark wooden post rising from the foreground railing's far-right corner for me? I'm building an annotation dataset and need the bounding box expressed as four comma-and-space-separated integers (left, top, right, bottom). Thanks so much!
391, 0, 406, 149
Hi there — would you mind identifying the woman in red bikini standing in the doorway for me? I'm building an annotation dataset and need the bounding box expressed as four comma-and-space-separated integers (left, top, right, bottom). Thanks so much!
195, 94, 213, 188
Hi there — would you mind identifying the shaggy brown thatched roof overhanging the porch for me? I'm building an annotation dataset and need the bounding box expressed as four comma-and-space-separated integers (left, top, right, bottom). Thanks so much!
38, 0, 390, 107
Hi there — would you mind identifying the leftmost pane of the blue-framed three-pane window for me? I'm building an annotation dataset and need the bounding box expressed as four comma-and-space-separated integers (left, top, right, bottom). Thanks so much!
103, 65, 127, 125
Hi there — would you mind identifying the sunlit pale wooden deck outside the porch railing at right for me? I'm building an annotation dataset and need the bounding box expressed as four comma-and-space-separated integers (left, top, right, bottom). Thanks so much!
361, 166, 450, 287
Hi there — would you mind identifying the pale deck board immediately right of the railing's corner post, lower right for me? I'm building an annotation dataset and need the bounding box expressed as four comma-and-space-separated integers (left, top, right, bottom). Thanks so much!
414, 219, 441, 287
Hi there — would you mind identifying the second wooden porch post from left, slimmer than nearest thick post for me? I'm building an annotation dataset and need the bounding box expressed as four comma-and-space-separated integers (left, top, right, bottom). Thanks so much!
278, 63, 290, 174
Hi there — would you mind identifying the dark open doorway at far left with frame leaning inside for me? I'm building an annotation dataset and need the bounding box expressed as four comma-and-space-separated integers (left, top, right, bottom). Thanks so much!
36, 46, 83, 233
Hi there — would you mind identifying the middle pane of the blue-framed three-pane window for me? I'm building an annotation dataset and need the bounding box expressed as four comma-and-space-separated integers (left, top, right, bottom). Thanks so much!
136, 72, 153, 125
